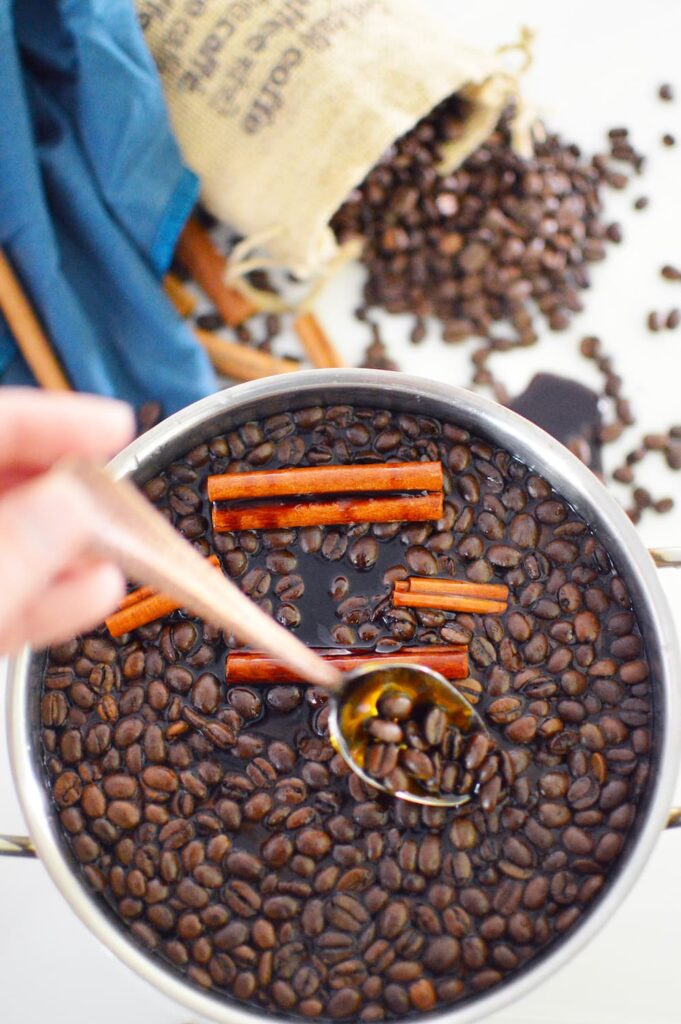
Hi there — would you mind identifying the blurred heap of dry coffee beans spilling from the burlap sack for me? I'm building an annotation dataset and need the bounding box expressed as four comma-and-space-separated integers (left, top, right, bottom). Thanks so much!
332, 95, 641, 345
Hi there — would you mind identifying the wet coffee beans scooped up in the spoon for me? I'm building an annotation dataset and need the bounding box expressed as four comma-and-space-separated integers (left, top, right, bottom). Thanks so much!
364, 691, 503, 809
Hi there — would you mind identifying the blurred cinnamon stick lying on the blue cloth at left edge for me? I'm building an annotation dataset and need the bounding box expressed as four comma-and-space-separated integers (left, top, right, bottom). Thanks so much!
0, 249, 71, 391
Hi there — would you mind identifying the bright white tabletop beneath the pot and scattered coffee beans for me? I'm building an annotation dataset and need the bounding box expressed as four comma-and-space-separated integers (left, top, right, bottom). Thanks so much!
0, 0, 681, 1024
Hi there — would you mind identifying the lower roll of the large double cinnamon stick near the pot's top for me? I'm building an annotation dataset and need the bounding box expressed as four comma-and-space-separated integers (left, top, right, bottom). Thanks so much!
213, 492, 443, 534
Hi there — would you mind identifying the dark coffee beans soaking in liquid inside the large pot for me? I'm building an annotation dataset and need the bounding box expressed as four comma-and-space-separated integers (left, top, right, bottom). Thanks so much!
41, 406, 655, 1021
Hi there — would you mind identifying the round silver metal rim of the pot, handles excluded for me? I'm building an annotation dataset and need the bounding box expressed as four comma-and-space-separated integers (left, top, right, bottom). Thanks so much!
7, 369, 681, 1024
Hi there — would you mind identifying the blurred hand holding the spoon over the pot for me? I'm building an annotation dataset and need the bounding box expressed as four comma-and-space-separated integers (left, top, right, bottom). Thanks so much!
0, 388, 134, 654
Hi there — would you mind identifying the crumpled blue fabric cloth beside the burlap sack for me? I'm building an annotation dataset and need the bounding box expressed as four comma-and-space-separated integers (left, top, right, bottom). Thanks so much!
0, 0, 215, 415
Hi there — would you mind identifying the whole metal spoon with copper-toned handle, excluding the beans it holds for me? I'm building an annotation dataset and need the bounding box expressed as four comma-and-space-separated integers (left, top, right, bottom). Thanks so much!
59, 460, 485, 807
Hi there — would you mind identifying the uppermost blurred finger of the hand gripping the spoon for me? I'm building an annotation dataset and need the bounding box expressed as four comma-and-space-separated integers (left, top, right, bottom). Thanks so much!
0, 388, 134, 470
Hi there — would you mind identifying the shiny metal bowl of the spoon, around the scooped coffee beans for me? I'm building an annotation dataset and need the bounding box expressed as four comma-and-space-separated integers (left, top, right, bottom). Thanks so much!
329, 657, 487, 807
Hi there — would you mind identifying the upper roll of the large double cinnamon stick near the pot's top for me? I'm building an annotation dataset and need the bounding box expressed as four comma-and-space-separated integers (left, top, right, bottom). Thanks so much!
208, 462, 442, 502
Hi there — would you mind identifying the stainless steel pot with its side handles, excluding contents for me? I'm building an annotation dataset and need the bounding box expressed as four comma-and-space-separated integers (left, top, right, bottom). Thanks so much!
5, 370, 681, 1024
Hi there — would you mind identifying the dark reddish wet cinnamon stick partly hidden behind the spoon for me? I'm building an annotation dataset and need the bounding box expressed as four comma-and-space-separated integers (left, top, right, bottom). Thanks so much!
225, 644, 468, 685
